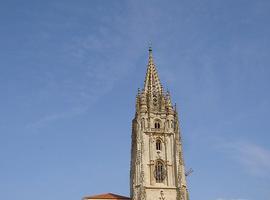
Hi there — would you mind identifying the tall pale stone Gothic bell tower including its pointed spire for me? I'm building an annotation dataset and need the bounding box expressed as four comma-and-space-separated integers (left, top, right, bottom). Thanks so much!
130, 48, 189, 200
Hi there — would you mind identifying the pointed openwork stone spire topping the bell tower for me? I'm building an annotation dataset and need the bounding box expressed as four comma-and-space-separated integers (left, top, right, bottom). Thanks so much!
144, 47, 162, 94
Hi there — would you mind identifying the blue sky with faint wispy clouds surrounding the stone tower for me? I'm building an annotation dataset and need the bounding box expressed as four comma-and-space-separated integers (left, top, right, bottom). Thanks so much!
0, 0, 270, 200
